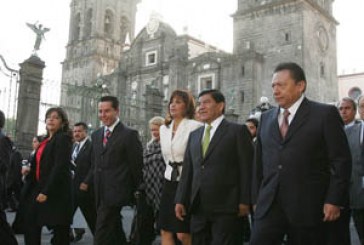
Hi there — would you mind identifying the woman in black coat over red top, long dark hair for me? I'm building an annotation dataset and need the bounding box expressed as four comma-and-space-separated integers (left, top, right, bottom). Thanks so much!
24, 107, 72, 245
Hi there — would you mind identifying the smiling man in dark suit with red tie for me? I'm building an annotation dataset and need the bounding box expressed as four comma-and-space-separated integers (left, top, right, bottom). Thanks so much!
85, 96, 143, 245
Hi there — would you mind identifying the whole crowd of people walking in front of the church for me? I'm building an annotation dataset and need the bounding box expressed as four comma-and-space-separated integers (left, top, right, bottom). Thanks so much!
0, 63, 364, 245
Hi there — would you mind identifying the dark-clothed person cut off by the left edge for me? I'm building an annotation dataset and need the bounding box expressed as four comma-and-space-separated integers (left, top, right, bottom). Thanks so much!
0, 111, 17, 245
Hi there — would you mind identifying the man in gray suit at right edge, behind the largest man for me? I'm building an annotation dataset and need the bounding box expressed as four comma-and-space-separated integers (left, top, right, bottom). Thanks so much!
339, 97, 364, 244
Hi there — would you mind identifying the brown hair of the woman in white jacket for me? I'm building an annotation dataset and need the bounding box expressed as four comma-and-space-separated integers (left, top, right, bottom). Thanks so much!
164, 89, 195, 126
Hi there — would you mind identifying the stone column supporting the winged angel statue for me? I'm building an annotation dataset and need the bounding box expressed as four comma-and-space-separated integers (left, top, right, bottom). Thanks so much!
16, 55, 45, 156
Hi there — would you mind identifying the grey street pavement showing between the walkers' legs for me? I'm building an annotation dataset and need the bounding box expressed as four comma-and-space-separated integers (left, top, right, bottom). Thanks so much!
5, 207, 360, 245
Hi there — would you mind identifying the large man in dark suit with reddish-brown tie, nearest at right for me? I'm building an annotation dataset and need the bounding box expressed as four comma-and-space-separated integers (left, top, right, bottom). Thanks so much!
250, 63, 351, 245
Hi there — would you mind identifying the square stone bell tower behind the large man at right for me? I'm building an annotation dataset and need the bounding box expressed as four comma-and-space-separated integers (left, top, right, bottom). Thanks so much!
233, 0, 338, 102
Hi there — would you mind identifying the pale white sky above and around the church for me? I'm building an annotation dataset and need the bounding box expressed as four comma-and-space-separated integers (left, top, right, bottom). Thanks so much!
0, 0, 364, 113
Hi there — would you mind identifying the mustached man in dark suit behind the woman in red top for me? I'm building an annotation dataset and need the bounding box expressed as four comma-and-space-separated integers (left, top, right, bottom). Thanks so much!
71, 122, 96, 241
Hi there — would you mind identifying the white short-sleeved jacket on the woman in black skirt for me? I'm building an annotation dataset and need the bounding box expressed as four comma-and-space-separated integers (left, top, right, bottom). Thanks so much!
160, 119, 203, 181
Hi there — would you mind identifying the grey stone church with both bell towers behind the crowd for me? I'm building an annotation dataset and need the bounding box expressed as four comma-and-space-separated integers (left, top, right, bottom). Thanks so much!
61, 0, 338, 142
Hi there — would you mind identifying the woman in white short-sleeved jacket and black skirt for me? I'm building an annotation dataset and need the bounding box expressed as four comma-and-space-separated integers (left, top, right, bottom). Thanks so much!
159, 90, 202, 245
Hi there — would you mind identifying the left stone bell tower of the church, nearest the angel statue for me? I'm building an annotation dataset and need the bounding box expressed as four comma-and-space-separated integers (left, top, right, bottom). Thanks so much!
61, 0, 140, 123
